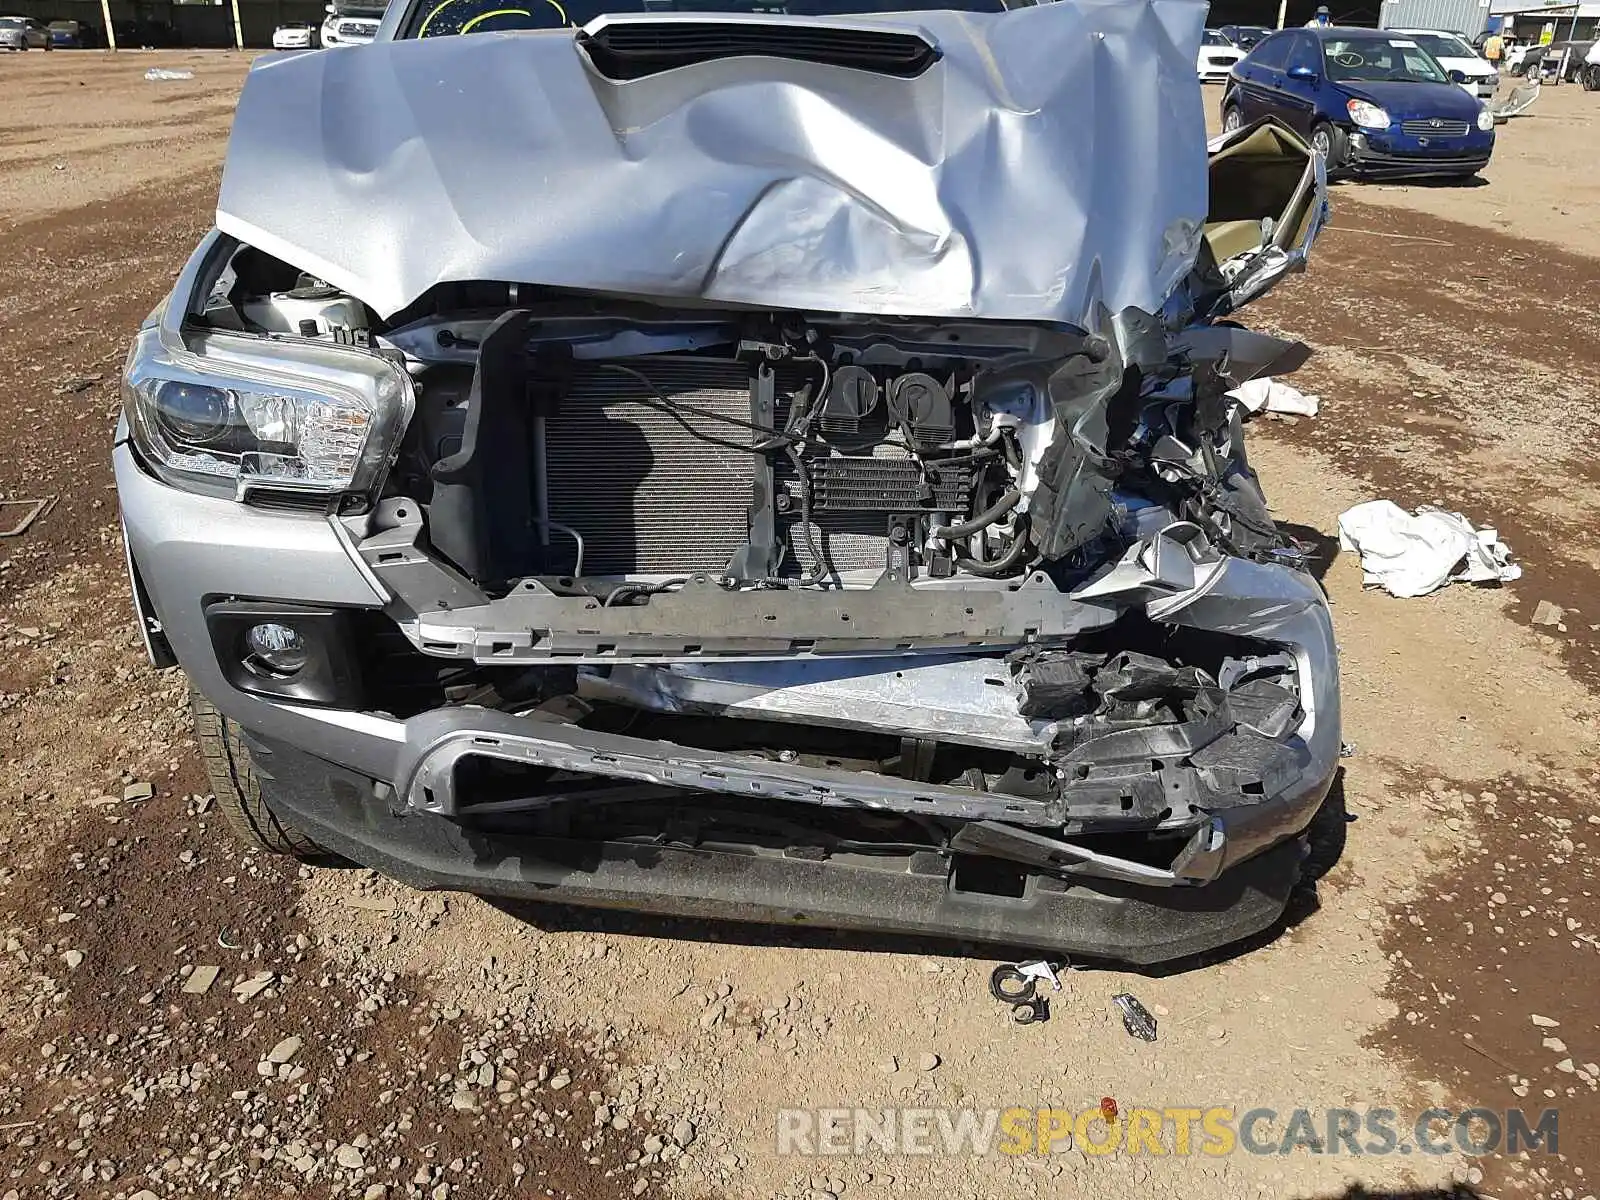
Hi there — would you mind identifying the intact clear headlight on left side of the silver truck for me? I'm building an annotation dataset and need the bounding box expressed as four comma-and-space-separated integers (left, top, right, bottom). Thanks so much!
123, 328, 413, 498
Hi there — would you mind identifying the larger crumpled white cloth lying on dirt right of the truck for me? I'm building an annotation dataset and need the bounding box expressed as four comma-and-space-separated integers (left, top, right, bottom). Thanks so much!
1339, 501, 1522, 597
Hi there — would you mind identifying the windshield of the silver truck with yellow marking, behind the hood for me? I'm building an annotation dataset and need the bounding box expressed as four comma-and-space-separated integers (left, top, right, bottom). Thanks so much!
400, 0, 1011, 37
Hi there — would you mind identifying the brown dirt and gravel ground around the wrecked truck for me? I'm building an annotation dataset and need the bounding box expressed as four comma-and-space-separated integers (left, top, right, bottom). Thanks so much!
0, 54, 1600, 1200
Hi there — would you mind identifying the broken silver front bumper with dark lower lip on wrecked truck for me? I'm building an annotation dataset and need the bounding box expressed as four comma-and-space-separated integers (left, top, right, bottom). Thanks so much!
114, 442, 1339, 962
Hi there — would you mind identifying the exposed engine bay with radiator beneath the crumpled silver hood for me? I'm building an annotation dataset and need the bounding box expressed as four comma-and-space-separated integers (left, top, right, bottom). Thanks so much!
205, 246, 1290, 606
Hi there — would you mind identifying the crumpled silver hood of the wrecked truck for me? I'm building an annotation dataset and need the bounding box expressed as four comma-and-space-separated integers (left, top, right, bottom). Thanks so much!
218, 0, 1206, 326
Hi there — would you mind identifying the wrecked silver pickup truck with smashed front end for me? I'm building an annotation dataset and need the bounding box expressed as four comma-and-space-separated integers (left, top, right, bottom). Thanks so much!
114, 0, 1339, 962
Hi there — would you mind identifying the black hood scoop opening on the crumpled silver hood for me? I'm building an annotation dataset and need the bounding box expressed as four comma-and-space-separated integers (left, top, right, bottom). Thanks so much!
578, 18, 939, 83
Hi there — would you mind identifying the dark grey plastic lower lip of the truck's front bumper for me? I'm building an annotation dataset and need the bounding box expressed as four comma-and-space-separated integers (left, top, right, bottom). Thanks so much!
250, 723, 1302, 963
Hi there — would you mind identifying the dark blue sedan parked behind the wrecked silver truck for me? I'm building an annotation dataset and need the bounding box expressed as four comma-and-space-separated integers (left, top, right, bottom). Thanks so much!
1222, 27, 1494, 179
